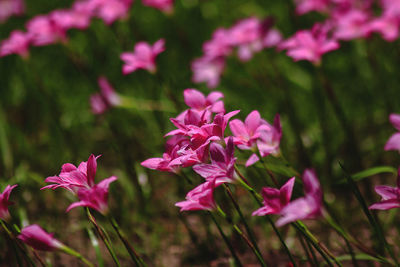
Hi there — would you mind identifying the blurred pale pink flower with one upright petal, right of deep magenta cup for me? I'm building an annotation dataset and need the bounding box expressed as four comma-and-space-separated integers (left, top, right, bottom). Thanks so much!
276, 169, 322, 226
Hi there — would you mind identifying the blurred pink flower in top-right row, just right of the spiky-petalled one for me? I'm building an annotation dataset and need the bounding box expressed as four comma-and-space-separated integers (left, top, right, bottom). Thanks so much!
333, 9, 371, 41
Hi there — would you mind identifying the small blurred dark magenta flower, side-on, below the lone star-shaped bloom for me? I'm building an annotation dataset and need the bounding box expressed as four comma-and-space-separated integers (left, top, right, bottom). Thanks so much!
90, 76, 121, 114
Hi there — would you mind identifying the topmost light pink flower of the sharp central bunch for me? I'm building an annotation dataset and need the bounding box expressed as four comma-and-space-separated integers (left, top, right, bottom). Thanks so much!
183, 88, 225, 113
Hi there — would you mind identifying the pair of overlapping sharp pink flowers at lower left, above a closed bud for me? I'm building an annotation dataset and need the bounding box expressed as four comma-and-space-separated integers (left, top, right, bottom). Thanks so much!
42, 154, 117, 215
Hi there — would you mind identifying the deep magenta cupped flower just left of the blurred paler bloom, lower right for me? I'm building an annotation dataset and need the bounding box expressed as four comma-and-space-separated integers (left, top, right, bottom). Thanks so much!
252, 177, 296, 216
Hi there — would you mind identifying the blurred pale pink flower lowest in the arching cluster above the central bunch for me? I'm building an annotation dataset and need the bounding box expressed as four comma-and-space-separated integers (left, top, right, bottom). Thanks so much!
192, 57, 225, 88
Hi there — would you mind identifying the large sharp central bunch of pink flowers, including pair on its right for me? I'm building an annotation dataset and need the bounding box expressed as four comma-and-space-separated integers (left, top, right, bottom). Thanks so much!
142, 89, 282, 210
